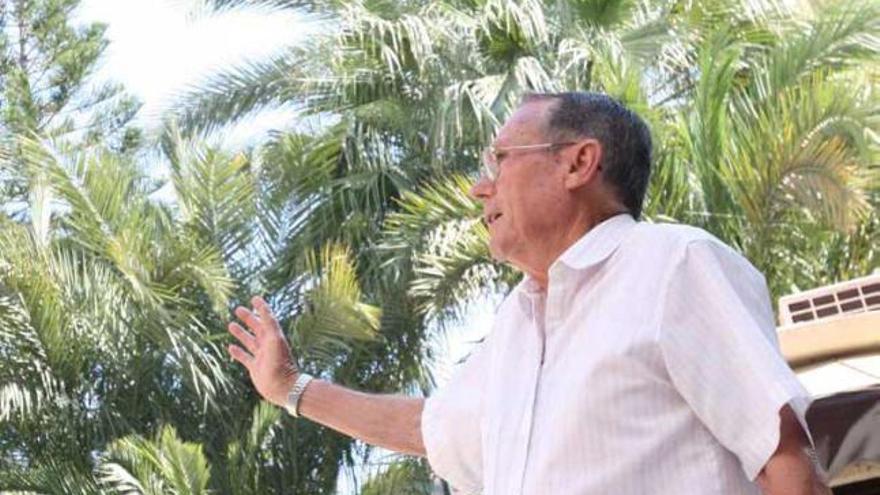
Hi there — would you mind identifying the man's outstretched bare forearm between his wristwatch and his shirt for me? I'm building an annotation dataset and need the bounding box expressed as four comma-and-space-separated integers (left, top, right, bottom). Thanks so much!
299, 380, 425, 456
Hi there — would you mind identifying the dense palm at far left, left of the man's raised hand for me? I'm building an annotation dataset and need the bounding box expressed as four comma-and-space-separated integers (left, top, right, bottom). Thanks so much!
0, 138, 232, 484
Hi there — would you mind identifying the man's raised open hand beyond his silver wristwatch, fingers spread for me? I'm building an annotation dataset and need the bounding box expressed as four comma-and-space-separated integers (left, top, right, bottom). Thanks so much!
229, 296, 299, 406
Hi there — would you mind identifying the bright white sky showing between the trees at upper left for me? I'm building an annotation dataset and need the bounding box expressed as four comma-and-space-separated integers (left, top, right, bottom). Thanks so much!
79, 0, 313, 143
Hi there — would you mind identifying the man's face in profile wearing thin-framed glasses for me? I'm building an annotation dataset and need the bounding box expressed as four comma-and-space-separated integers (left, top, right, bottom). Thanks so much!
471, 101, 568, 268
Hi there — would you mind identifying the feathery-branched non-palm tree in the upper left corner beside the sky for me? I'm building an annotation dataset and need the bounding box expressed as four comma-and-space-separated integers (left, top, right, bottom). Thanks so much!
0, 0, 141, 207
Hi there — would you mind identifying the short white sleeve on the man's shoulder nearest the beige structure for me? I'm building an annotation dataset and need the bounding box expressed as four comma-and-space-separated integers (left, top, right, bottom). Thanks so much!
658, 239, 812, 480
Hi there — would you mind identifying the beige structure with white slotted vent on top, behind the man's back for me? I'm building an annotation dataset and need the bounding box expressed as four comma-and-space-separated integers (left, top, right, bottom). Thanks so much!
777, 272, 880, 494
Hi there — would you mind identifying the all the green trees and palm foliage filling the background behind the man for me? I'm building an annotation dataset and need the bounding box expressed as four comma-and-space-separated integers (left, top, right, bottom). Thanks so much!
0, 0, 880, 494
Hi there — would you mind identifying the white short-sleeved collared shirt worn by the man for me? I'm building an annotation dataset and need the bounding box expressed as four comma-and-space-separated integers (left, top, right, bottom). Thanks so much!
422, 215, 809, 495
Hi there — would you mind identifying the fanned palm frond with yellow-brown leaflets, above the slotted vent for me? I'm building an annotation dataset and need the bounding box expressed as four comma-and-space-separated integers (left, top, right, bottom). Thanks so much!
725, 77, 876, 234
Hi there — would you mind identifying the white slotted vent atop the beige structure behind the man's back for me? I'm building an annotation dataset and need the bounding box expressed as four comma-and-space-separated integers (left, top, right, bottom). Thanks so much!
779, 273, 880, 325
